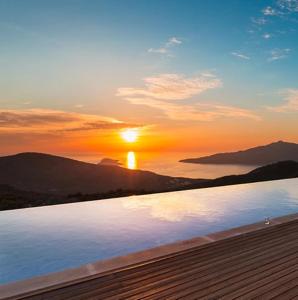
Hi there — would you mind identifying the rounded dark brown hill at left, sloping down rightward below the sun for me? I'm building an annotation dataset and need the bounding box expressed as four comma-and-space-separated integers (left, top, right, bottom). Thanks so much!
0, 153, 198, 195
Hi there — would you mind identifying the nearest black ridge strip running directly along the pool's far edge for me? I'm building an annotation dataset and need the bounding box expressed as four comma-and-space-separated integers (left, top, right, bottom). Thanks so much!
0, 161, 298, 210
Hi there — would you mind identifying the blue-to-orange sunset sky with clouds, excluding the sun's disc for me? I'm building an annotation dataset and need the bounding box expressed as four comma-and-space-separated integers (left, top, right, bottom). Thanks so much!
0, 0, 298, 154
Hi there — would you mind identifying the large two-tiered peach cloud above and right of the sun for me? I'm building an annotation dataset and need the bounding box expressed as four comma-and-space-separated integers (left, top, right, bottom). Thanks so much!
117, 73, 260, 121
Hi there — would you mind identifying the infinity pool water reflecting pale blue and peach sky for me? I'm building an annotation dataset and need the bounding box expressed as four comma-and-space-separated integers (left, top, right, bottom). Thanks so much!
0, 178, 298, 283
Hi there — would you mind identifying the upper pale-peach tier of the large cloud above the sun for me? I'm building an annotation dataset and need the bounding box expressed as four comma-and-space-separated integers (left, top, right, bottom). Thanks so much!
117, 74, 222, 100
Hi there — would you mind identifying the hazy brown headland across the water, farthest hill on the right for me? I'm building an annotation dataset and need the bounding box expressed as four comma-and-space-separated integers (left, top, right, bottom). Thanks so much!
180, 141, 298, 165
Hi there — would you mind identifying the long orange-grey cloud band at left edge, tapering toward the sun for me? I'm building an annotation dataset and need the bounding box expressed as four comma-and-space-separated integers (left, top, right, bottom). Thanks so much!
0, 109, 138, 133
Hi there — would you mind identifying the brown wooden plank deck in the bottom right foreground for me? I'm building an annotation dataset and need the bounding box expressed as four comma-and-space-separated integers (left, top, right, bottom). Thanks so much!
0, 215, 298, 300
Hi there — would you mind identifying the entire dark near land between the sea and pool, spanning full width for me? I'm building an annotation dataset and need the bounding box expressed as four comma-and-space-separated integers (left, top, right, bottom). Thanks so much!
0, 153, 298, 210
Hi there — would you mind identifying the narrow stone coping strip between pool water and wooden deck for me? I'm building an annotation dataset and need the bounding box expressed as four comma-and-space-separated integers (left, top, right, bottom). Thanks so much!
0, 213, 298, 300
